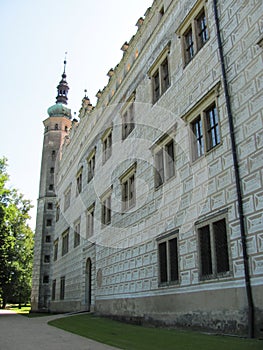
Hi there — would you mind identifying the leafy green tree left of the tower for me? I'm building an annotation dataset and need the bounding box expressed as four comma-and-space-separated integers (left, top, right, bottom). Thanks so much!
0, 158, 33, 308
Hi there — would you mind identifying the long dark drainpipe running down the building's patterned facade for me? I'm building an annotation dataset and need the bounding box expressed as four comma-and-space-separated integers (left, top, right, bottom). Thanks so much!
213, 0, 254, 338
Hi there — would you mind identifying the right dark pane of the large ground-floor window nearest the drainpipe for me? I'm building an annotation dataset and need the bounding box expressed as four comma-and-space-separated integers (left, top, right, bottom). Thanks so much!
213, 219, 229, 273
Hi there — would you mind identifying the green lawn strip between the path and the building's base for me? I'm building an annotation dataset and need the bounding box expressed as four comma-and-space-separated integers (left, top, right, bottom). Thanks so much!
49, 314, 263, 350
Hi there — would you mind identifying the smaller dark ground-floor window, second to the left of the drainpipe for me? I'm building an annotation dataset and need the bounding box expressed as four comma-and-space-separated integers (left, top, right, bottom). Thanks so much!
158, 231, 179, 285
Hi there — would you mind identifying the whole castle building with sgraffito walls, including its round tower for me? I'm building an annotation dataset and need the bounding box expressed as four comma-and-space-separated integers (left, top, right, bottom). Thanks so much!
32, 0, 263, 336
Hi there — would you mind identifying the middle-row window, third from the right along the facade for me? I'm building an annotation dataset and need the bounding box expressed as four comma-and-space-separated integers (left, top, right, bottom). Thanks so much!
120, 163, 137, 211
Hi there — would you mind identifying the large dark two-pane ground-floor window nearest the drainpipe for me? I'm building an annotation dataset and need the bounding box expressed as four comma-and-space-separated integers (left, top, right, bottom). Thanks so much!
197, 218, 229, 280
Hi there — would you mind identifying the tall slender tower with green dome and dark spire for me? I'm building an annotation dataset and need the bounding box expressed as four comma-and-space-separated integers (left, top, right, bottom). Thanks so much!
31, 60, 71, 312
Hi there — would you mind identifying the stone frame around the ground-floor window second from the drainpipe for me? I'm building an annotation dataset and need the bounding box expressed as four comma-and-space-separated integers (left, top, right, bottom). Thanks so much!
157, 230, 180, 287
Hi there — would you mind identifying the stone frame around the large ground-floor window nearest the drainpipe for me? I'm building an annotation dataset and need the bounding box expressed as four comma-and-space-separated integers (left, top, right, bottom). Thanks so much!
195, 214, 231, 281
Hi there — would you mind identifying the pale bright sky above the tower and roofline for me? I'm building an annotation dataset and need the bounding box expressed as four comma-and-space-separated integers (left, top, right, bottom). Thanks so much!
0, 0, 153, 230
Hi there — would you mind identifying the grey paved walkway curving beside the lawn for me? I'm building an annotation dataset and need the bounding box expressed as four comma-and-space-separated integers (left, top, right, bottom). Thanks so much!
0, 310, 116, 350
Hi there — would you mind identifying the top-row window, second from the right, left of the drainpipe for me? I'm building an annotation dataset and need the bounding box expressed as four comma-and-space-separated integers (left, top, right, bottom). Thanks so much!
148, 43, 170, 103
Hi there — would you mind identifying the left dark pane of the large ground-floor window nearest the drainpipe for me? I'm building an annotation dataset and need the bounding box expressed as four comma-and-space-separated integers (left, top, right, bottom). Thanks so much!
198, 225, 213, 277
